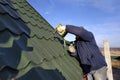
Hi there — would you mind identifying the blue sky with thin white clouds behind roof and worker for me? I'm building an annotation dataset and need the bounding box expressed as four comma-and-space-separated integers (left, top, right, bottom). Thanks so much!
27, 0, 120, 47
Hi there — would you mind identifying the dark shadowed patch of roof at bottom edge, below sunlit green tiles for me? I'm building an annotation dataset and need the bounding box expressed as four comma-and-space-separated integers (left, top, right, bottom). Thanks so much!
18, 67, 66, 80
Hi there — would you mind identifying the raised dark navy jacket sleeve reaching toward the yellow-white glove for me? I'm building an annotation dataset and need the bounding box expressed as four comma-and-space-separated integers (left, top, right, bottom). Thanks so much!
66, 25, 93, 41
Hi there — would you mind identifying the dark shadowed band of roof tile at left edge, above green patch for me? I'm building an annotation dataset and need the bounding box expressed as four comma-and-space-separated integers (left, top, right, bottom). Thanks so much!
0, 14, 30, 36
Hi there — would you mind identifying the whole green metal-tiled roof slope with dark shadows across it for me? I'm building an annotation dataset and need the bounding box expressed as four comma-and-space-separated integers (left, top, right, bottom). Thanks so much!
0, 0, 82, 80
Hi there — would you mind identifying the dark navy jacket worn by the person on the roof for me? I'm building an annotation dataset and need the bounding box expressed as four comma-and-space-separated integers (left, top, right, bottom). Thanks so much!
66, 25, 107, 74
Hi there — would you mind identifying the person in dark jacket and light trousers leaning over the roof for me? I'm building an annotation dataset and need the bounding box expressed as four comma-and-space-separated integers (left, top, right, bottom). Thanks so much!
56, 25, 107, 80
